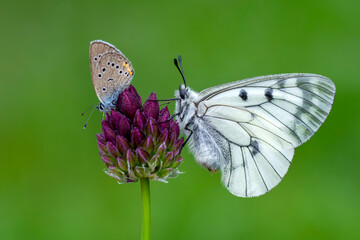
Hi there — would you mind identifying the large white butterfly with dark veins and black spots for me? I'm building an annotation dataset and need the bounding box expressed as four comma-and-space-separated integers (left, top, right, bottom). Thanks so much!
175, 56, 335, 197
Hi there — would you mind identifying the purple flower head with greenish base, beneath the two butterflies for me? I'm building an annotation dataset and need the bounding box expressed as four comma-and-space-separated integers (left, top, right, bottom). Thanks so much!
97, 85, 184, 183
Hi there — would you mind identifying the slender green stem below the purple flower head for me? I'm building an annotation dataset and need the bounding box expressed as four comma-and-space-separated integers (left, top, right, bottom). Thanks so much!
140, 178, 150, 240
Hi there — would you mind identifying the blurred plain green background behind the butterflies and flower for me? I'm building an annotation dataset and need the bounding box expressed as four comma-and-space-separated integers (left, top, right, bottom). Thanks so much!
0, 0, 360, 240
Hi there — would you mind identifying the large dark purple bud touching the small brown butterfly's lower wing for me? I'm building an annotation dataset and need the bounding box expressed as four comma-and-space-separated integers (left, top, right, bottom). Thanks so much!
116, 89, 141, 120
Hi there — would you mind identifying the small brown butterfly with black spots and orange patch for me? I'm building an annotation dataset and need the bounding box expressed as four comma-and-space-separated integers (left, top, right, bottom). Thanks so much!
90, 40, 134, 112
